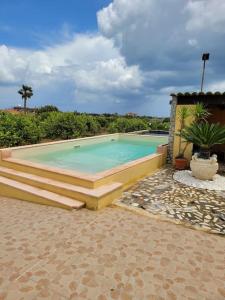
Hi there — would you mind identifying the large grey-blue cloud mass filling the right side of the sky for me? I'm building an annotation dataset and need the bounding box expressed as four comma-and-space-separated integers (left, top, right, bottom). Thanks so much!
98, 0, 225, 113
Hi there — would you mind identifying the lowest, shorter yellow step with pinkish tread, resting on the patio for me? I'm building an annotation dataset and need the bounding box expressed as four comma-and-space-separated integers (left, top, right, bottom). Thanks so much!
0, 176, 85, 209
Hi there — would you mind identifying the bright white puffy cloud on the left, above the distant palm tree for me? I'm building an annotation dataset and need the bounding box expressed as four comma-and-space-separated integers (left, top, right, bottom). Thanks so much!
0, 35, 142, 109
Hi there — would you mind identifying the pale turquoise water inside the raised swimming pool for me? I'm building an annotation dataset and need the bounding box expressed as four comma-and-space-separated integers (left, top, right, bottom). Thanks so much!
22, 140, 166, 174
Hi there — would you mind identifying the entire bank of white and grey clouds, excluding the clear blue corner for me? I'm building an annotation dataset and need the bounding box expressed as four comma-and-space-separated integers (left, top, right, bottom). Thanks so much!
0, 0, 225, 115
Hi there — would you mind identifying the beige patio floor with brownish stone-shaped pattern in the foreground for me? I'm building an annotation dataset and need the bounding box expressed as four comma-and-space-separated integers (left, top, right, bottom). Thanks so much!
0, 198, 225, 300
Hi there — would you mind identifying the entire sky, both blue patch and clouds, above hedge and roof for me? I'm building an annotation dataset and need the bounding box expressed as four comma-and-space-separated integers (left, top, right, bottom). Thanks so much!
0, 0, 225, 116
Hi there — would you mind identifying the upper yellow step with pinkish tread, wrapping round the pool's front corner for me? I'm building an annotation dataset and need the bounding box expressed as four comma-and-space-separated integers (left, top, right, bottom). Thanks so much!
0, 166, 122, 210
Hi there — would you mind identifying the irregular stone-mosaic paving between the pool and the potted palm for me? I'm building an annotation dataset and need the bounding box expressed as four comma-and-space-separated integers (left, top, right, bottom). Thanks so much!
117, 167, 225, 235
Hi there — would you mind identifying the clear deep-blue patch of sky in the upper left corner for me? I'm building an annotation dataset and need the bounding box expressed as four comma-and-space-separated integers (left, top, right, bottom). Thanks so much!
0, 0, 110, 49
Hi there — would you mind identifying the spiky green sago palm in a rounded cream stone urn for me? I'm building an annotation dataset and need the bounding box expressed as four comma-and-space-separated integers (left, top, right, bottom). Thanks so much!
180, 121, 225, 180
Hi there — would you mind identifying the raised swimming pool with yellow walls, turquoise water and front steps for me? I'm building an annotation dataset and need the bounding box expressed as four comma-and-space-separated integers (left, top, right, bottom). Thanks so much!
0, 133, 168, 210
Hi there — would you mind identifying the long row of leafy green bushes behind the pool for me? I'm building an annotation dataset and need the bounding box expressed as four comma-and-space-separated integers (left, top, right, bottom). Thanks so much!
0, 105, 169, 147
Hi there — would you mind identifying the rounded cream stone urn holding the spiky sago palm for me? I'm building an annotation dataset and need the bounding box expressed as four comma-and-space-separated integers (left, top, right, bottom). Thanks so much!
190, 154, 219, 180
